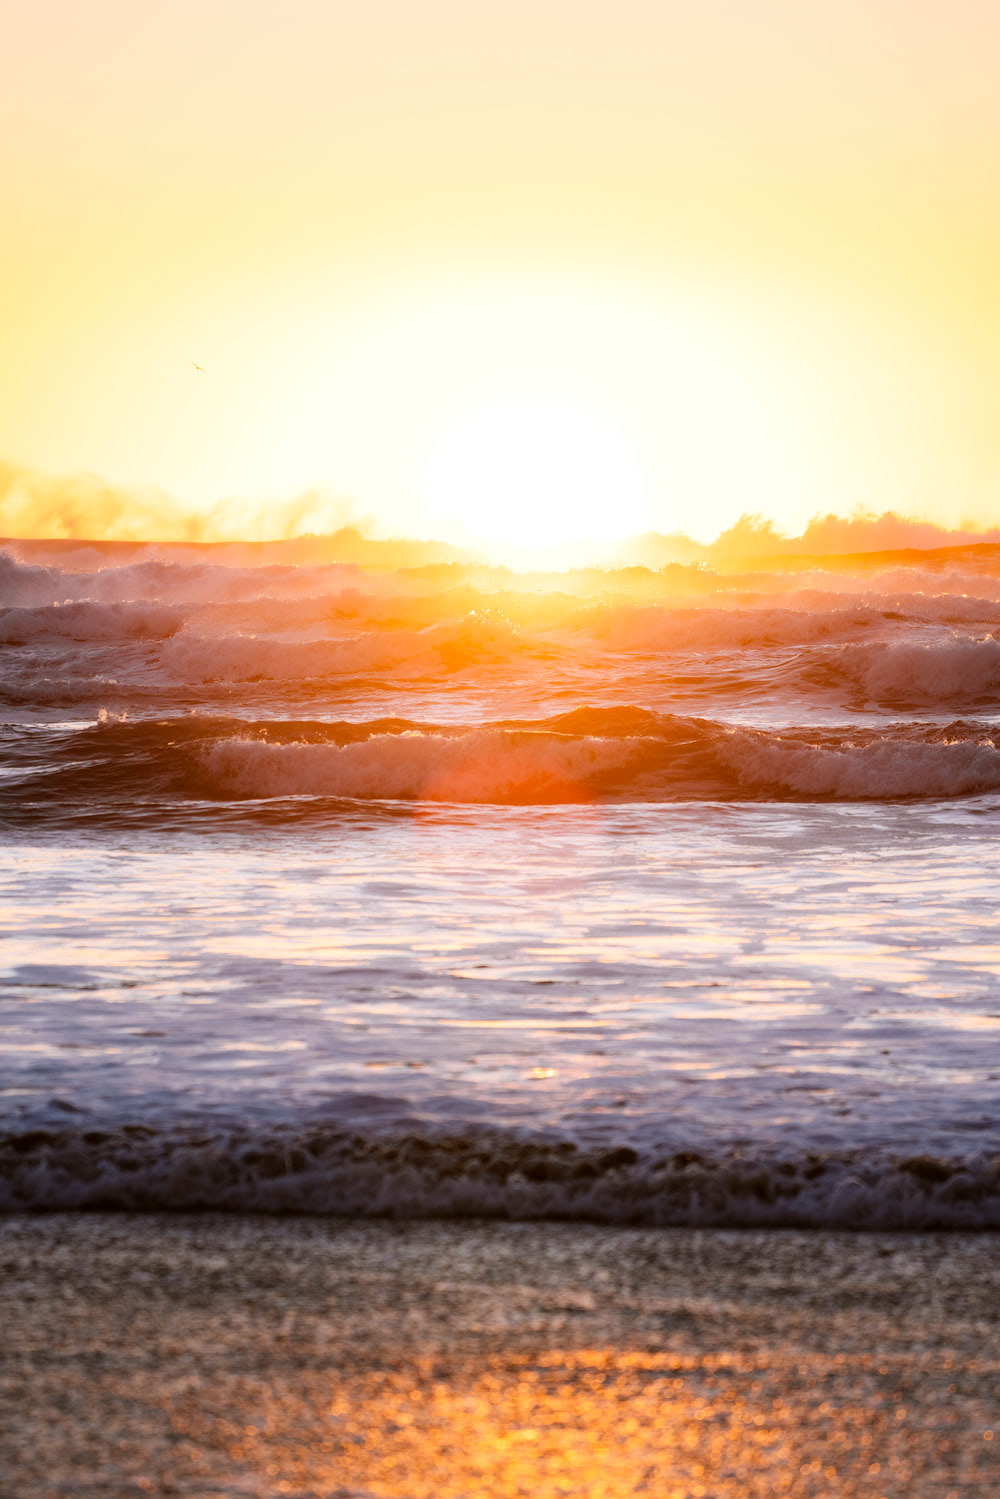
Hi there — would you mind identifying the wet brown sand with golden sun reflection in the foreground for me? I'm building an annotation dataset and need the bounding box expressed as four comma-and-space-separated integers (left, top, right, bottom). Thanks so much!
0, 1214, 1000, 1499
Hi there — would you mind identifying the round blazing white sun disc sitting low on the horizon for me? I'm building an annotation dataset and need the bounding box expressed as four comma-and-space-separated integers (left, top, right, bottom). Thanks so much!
424, 390, 651, 550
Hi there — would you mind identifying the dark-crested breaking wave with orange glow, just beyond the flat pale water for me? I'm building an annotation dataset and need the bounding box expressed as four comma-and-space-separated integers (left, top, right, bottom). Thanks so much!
0, 708, 1000, 818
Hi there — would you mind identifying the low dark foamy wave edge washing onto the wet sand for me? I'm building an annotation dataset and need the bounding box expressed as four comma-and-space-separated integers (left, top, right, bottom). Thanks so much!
0, 1124, 1000, 1229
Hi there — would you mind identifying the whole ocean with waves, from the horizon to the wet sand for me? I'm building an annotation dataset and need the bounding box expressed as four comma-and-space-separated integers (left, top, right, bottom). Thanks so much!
0, 541, 1000, 1229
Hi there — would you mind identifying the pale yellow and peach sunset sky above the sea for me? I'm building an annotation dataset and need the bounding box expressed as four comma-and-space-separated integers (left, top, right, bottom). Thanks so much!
0, 0, 1000, 546
